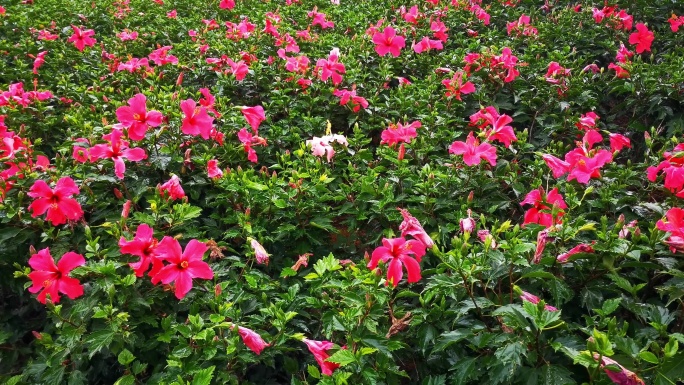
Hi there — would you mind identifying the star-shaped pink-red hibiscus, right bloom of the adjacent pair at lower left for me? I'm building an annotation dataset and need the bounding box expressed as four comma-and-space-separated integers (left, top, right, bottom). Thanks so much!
152, 237, 214, 299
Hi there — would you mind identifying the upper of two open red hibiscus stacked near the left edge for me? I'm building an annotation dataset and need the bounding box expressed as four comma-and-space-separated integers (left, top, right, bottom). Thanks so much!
28, 176, 83, 226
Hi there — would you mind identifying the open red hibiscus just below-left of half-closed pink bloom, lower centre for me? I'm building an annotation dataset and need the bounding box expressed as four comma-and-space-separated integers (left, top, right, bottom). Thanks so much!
368, 237, 425, 287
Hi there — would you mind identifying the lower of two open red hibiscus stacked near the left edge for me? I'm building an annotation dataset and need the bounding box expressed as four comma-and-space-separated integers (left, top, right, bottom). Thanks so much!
28, 248, 85, 304
